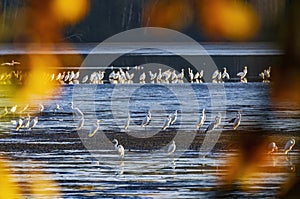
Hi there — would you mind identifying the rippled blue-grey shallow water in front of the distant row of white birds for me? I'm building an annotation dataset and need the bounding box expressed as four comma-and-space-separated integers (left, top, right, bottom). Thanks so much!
0, 83, 300, 198
